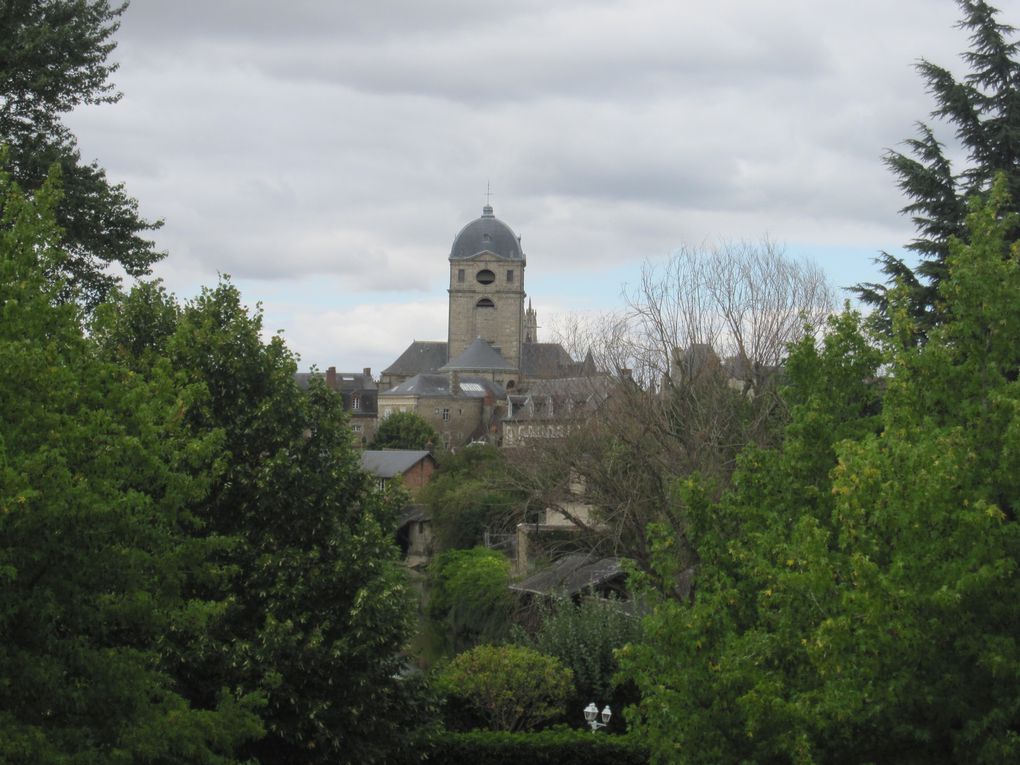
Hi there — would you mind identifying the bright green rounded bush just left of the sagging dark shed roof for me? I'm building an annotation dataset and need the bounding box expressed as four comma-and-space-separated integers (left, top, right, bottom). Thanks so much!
427, 547, 513, 653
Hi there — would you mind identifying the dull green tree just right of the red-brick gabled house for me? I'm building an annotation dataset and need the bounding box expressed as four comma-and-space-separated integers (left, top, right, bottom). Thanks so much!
419, 445, 522, 550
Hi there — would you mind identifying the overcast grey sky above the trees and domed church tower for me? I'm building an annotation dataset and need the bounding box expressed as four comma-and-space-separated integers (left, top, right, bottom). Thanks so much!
68, 0, 979, 373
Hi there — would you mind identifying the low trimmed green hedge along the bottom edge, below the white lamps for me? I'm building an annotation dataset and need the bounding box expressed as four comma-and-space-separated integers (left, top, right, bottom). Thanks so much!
410, 728, 650, 765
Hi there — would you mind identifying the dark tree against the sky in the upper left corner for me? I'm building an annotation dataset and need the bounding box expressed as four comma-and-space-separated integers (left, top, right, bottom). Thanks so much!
0, 0, 163, 307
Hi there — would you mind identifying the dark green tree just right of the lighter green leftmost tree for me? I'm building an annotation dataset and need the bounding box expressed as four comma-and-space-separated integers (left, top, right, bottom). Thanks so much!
100, 282, 413, 763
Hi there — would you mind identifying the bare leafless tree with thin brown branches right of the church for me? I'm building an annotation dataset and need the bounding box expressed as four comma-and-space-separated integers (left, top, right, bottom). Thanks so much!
513, 240, 833, 597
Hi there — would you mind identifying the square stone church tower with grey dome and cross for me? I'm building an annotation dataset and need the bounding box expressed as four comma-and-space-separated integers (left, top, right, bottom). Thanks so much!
447, 205, 534, 369
